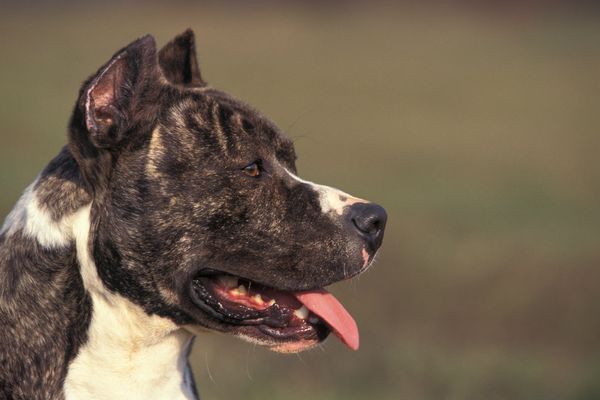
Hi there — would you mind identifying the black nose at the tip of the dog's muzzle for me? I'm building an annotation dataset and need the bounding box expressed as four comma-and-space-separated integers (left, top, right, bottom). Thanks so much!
348, 203, 387, 251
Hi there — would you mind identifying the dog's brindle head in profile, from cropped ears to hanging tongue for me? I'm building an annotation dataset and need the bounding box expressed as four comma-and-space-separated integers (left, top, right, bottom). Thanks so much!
69, 31, 386, 351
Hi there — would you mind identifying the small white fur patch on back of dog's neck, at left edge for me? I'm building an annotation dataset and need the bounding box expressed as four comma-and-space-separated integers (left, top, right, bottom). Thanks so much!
0, 179, 72, 247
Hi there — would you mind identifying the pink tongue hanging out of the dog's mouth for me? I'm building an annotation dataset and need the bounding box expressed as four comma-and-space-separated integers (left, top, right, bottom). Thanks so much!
294, 289, 358, 350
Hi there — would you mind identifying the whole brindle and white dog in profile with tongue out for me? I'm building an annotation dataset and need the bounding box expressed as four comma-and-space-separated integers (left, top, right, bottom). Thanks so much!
0, 30, 387, 400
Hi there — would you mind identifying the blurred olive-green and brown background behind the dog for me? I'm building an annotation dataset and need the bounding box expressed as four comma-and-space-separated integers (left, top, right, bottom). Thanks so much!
0, 2, 600, 400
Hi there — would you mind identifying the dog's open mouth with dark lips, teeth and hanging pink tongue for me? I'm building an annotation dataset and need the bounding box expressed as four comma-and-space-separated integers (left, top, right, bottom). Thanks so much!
191, 271, 358, 351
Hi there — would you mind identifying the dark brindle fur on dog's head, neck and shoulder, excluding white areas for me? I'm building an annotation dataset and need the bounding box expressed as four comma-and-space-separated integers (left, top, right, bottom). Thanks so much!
0, 30, 384, 399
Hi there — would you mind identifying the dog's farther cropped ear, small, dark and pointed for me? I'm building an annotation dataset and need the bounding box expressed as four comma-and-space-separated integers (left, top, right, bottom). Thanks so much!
158, 29, 206, 87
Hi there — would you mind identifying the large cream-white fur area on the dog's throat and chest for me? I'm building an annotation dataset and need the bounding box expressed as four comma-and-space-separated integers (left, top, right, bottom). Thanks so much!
64, 206, 195, 400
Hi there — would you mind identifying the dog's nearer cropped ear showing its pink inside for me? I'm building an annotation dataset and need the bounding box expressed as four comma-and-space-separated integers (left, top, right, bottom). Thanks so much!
79, 35, 159, 148
